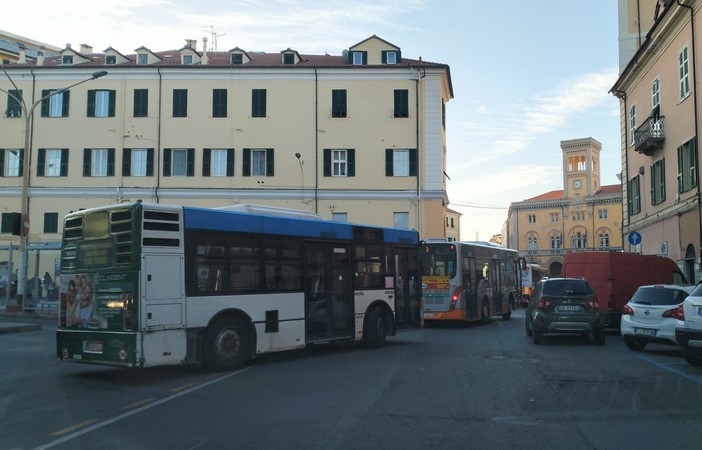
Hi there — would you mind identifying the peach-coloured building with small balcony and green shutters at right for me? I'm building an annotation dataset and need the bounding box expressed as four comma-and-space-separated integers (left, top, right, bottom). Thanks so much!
611, 0, 702, 282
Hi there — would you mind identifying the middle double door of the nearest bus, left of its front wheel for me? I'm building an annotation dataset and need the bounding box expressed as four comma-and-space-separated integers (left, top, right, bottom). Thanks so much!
305, 242, 354, 341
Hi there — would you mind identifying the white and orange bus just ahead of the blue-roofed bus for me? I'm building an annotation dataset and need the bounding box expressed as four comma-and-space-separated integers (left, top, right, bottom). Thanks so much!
421, 239, 520, 322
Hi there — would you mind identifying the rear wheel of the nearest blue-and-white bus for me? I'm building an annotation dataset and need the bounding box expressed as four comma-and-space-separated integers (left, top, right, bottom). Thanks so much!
202, 317, 251, 370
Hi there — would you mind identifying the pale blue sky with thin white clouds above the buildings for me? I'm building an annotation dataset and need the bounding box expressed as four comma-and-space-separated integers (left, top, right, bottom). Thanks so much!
0, 0, 621, 240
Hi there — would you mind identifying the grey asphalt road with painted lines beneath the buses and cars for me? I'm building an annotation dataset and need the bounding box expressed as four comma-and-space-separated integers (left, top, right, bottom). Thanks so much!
0, 311, 702, 449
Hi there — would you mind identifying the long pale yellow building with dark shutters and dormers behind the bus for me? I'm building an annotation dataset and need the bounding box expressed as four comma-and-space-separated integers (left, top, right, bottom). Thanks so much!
0, 36, 453, 274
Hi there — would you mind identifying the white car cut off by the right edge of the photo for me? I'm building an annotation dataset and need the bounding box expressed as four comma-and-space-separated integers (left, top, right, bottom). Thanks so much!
675, 283, 702, 366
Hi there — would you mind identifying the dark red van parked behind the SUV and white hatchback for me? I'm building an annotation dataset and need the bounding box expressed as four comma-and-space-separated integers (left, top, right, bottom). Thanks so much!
561, 251, 687, 329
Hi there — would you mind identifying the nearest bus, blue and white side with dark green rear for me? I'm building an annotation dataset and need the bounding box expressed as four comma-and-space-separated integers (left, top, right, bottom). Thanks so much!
56, 202, 423, 370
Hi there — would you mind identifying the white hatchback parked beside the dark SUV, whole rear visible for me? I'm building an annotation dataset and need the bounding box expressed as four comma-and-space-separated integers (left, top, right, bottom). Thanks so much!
620, 284, 695, 350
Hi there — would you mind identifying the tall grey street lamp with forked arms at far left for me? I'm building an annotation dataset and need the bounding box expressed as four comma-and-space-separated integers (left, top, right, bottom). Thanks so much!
0, 64, 107, 310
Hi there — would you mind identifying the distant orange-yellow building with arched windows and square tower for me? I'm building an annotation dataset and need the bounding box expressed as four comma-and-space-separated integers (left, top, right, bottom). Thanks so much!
503, 138, 622, 276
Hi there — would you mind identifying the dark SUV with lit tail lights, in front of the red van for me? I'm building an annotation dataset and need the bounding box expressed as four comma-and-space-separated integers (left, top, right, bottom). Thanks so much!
526, 278, 605, 345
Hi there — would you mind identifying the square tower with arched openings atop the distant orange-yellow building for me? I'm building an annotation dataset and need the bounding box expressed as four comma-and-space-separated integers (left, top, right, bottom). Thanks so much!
561, 137, 602, 198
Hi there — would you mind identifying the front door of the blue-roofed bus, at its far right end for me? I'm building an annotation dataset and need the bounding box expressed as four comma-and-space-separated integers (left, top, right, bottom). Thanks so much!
394, 248, 422, 329
